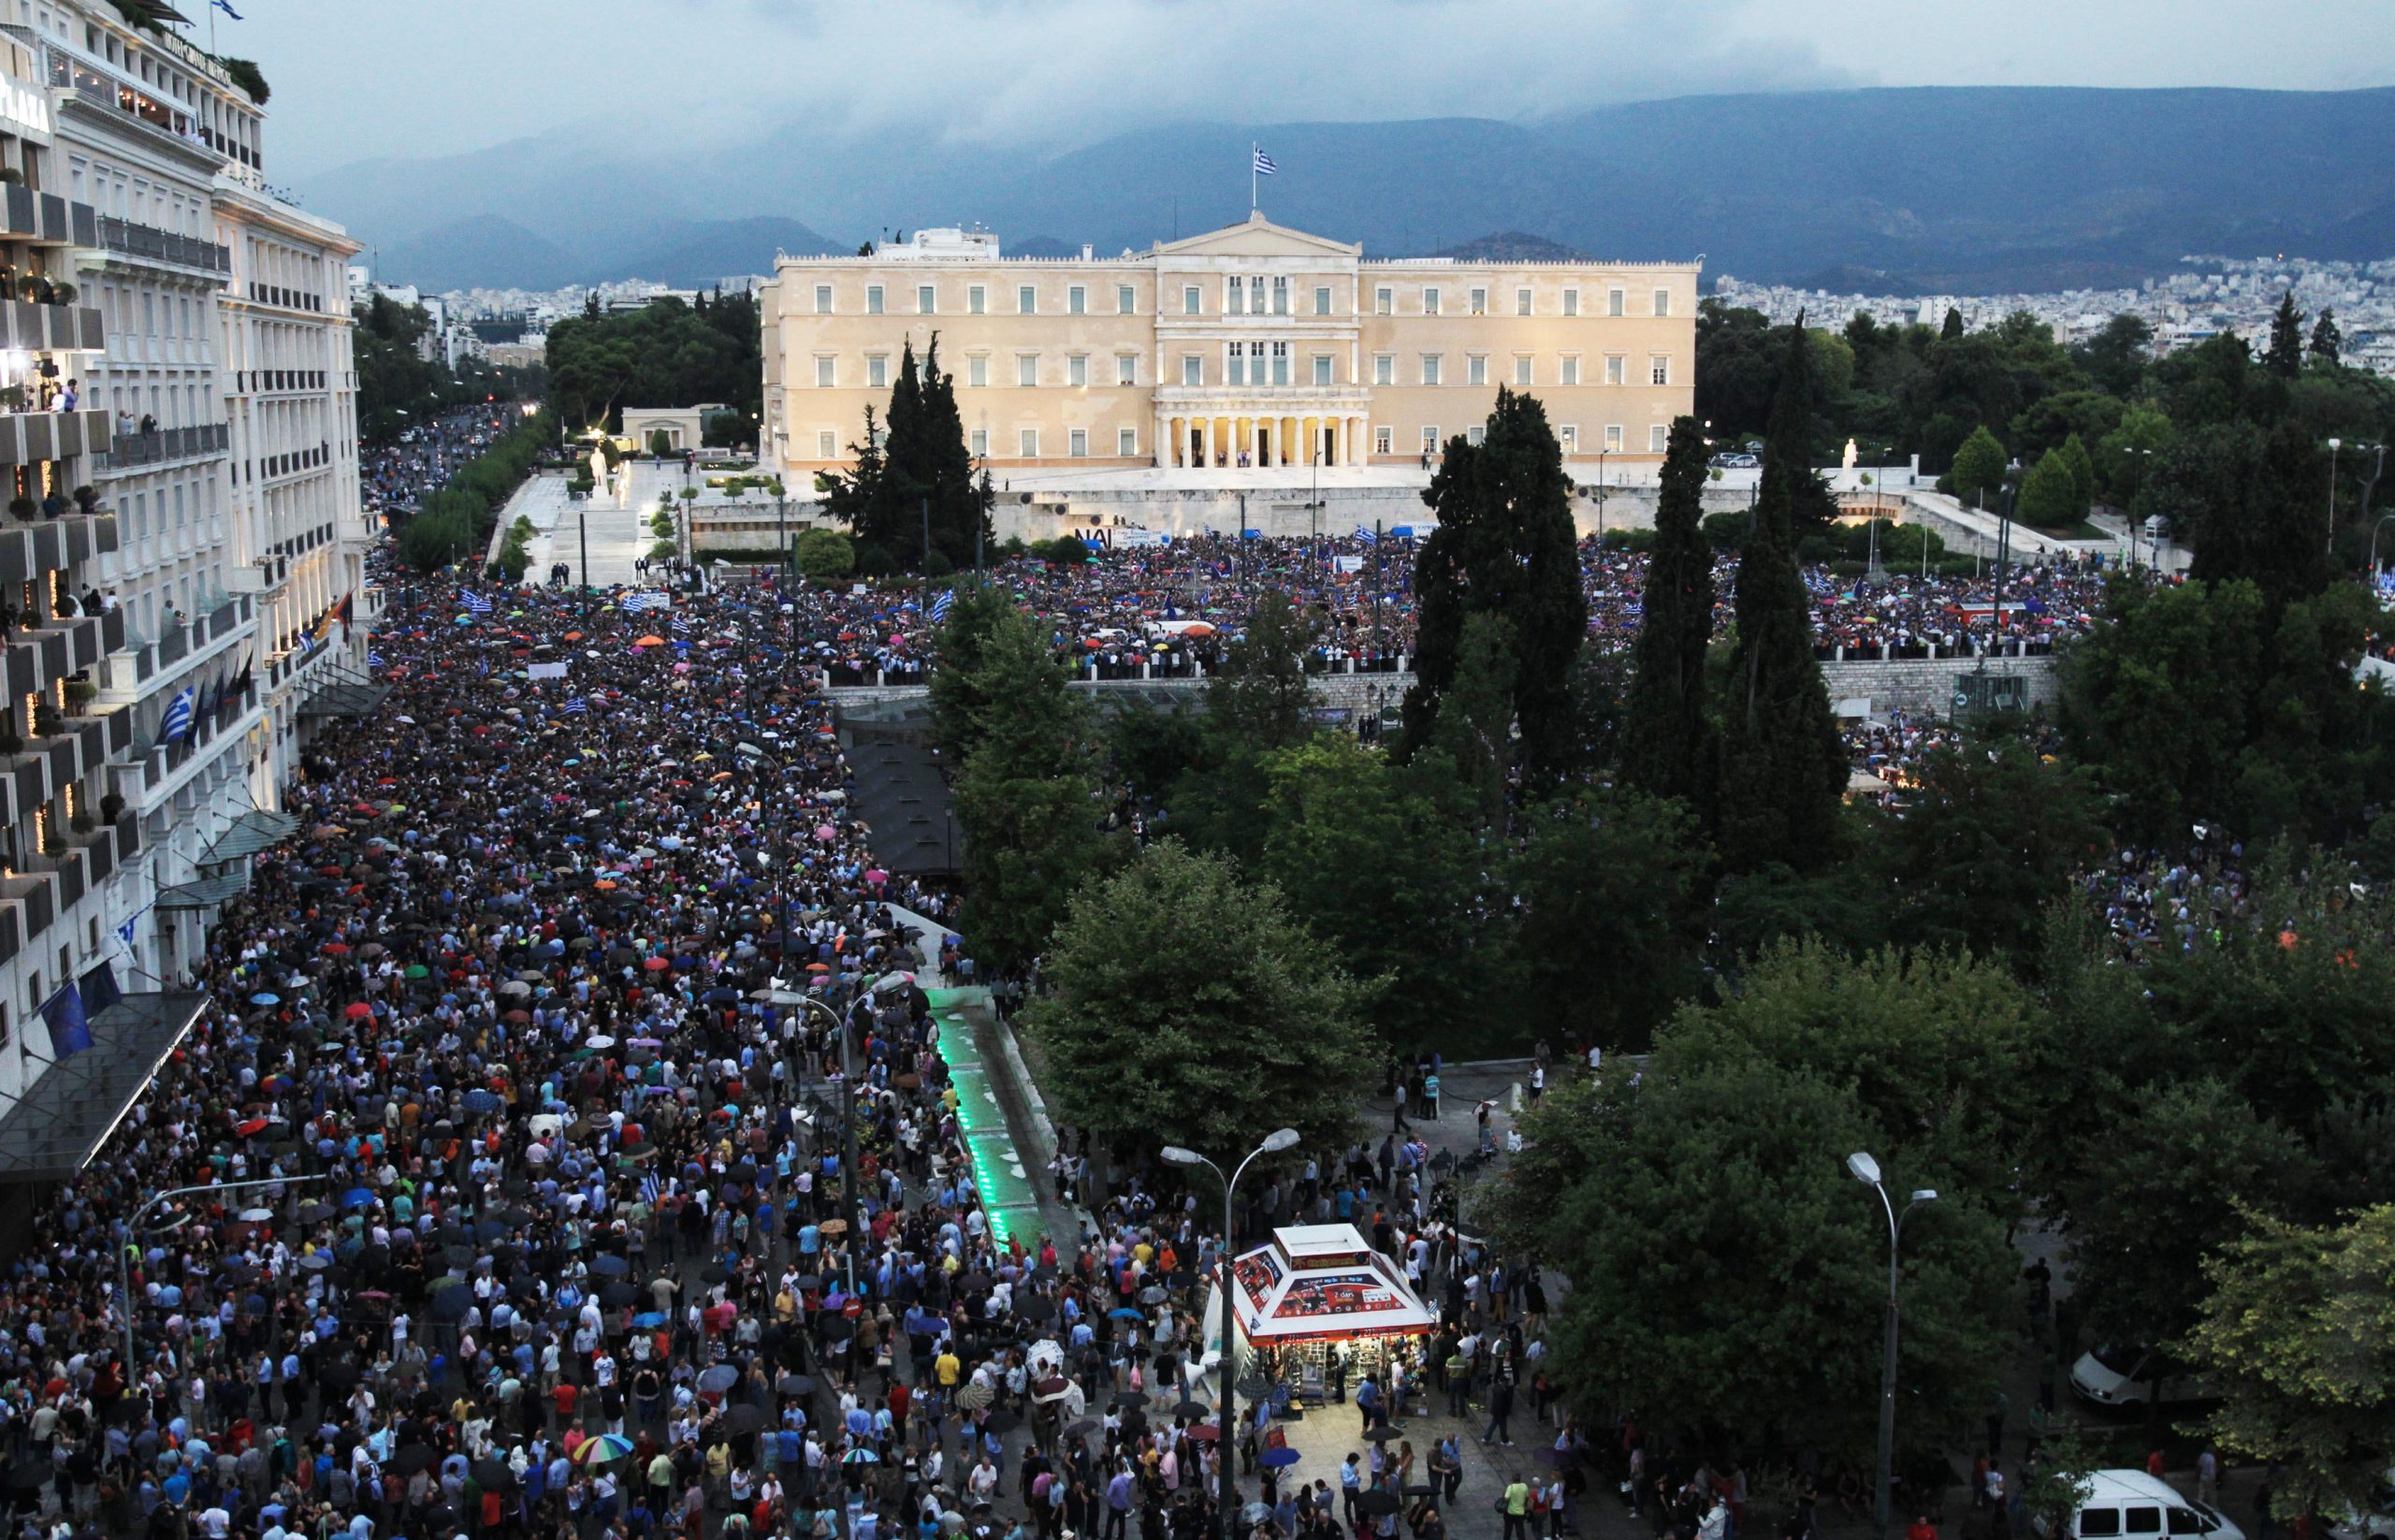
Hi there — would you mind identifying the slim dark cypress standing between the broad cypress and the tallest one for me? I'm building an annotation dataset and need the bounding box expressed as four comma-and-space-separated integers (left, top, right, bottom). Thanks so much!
1621, 416, 1715, 809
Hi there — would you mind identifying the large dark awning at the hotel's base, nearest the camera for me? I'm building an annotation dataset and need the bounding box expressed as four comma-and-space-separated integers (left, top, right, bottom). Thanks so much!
0, 989, 209, 1181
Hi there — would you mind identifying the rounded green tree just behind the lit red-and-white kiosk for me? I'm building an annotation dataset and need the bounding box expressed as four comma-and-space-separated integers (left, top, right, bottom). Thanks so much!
1025, 841, 1377, 1162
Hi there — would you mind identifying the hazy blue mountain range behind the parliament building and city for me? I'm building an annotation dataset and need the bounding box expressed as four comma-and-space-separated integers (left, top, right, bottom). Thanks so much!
309, 86, 2395, 292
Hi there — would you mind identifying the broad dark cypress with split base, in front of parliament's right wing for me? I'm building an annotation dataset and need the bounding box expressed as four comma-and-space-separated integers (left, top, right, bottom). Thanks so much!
1406, 385, 1588, 786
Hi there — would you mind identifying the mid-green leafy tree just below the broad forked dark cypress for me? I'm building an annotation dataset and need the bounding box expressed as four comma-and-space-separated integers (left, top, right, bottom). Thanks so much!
1255, 735, 1485, 1056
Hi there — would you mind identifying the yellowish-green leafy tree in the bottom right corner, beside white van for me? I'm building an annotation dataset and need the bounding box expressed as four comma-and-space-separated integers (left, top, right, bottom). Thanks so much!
2191, 1202, 2395, 1521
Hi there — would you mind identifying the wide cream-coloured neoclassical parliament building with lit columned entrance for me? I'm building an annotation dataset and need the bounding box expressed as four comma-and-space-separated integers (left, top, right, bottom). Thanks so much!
760, 213, 1698, 472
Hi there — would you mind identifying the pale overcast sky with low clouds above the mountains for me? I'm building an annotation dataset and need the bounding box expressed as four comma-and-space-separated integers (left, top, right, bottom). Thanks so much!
215, 0, 2395, 189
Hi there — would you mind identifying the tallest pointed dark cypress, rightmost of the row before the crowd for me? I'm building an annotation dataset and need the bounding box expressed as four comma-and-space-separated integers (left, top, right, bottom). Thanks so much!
1720, 316, 1847, 872
